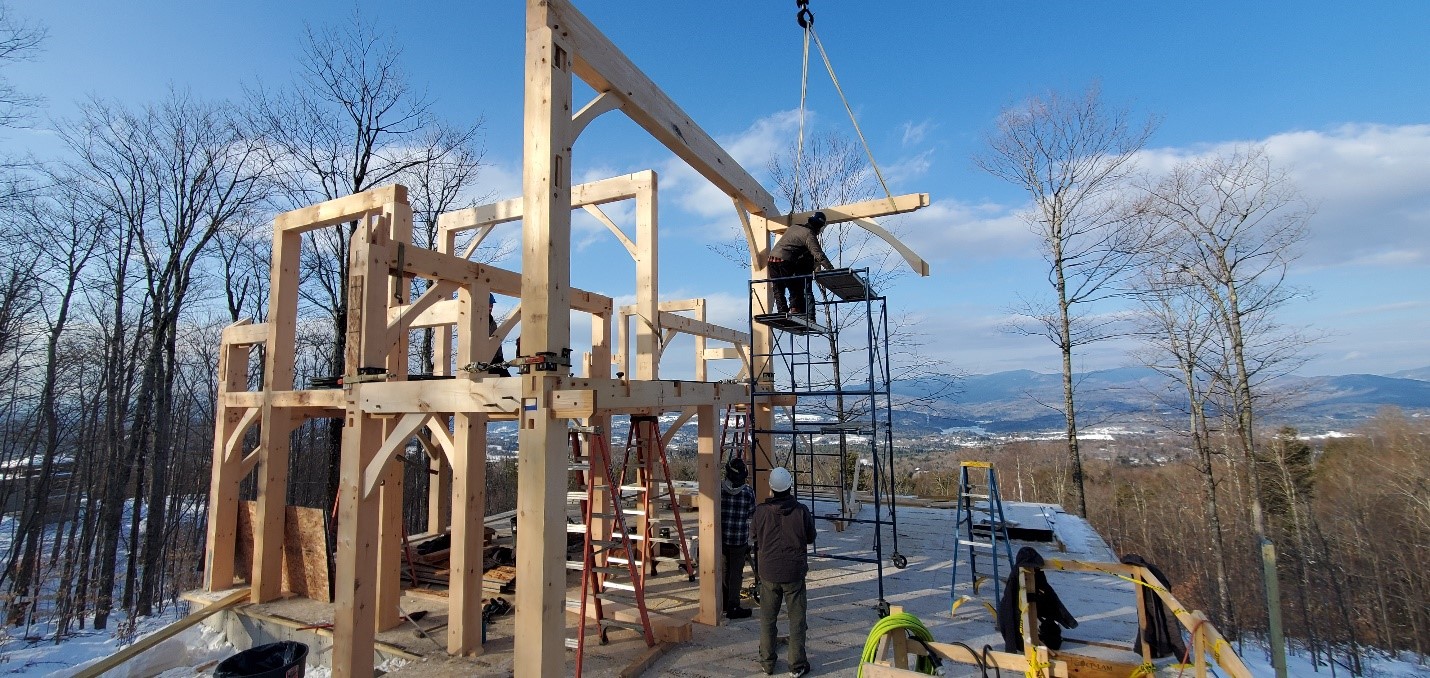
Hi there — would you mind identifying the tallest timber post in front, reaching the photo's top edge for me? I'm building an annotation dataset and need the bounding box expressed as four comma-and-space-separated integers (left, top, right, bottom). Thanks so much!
513, 0, 572, 677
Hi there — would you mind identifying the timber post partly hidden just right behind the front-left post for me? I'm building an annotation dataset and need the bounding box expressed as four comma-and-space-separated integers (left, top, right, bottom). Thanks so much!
374, 202, 412, 631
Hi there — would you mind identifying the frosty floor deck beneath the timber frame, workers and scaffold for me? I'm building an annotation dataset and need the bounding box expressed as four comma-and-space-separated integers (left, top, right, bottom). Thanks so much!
204, 502, 1174, 678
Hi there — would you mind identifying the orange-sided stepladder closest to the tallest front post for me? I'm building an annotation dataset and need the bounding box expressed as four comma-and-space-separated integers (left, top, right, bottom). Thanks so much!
566, 426, 655, 677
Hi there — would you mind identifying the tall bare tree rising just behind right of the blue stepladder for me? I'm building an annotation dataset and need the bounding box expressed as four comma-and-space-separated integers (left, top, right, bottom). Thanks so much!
974, 84, 1155, 516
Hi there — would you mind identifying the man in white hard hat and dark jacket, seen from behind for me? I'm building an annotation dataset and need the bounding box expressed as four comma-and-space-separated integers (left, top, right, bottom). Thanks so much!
752, 468, 815, 677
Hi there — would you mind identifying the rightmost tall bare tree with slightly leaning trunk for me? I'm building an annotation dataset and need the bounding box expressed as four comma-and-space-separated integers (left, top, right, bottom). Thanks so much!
1141, 146, 1311, 675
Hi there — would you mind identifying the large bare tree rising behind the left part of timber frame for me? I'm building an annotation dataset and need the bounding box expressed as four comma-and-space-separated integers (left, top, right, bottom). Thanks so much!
250, 11, 482, 501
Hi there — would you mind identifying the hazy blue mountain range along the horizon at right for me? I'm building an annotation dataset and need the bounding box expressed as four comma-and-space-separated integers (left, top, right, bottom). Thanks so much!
895, 368, 1430, 433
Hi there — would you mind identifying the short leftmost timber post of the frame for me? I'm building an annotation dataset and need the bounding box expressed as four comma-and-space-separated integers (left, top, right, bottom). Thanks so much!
203, 336, 249, 591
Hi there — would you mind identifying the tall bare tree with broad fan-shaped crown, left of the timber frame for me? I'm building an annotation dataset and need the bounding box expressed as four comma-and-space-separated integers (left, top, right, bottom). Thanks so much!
61, 92, 266, 628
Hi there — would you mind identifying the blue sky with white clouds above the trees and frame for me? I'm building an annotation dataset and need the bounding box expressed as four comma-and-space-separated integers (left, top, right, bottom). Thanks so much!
0, 0, 1430, 375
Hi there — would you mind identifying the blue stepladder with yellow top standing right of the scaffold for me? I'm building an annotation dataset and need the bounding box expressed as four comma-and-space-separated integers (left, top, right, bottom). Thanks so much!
948, 462, 1012, 619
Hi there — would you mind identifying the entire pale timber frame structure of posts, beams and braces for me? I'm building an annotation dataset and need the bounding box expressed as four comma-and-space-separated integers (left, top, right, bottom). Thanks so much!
204, 0, 928, 677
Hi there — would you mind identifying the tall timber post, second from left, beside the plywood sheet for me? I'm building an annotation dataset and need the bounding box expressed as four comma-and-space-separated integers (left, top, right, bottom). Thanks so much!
249, 230, 302, 602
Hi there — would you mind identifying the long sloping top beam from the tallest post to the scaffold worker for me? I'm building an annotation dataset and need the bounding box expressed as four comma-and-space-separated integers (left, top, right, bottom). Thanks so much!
549, 0, 778, 216
